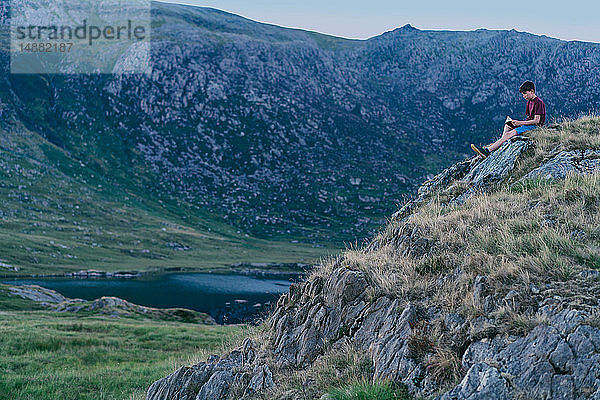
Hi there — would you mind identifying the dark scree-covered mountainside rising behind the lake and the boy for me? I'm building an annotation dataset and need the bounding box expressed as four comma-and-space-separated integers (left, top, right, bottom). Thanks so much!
0, 0, 600, 243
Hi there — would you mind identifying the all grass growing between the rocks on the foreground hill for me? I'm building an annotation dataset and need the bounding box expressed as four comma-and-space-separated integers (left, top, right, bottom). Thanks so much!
255, 116, 600, 399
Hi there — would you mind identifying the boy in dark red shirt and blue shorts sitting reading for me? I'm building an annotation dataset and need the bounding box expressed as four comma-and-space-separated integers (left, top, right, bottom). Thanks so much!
471, 81, 546, 158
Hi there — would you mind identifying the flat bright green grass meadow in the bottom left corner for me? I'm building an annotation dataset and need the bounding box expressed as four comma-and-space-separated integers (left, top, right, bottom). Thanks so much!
0, 311, 247, 400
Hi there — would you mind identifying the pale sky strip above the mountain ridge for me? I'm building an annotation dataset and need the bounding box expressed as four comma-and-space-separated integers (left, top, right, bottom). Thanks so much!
156, 0, 600, 43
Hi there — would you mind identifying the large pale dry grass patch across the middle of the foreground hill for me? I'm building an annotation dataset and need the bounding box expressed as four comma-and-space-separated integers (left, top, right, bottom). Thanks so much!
341, 170, 600, 309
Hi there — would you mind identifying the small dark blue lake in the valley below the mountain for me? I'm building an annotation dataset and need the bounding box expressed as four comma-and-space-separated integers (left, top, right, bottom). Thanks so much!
3, 273, 298, 324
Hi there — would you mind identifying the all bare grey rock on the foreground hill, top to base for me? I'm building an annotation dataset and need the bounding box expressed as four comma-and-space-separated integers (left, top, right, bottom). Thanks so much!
148, 138, 600, 400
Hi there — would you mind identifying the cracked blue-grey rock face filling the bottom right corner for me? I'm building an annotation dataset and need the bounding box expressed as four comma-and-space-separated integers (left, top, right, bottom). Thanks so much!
439, 304, 600, 400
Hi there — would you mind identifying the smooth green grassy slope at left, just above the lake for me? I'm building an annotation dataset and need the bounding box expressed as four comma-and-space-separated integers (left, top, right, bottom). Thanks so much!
0, 123, 333, 275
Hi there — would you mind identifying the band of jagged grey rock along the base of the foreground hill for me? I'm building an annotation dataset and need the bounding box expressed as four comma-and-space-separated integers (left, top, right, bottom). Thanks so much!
147, 267, 600, 400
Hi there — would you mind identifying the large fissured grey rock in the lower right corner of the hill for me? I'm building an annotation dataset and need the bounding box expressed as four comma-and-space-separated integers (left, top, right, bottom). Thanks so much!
454, 316, 600, 399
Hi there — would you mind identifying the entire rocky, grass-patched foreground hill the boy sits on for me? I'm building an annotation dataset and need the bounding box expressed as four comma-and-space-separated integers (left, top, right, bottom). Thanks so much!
147, 117, 600, 400
